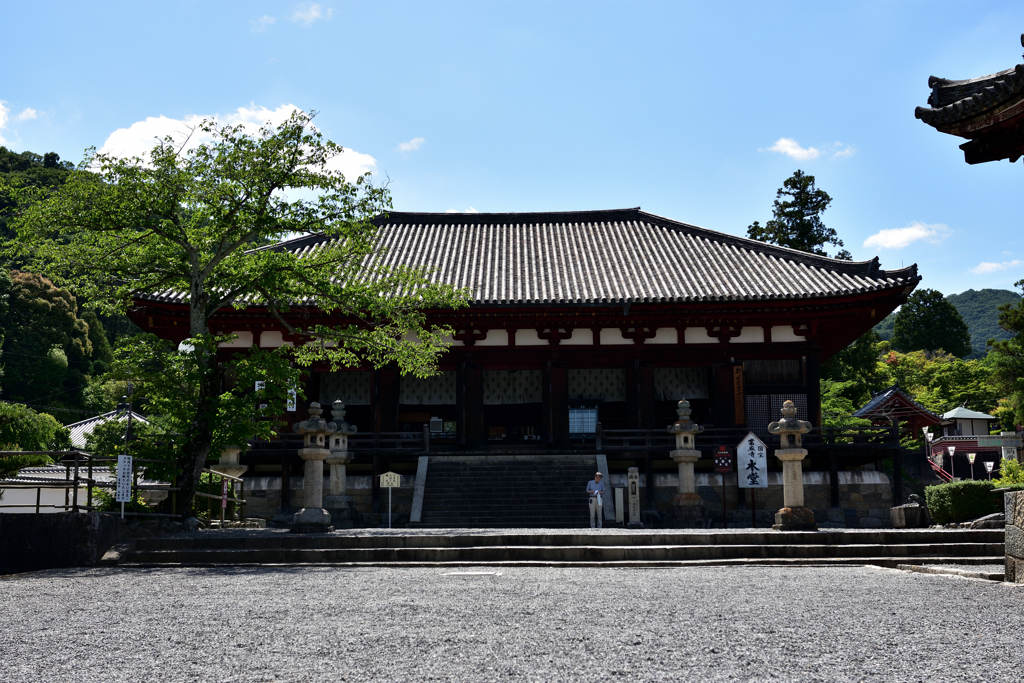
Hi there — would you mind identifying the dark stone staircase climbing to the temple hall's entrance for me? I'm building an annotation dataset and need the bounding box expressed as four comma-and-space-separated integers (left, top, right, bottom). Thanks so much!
413, 456, 597, 528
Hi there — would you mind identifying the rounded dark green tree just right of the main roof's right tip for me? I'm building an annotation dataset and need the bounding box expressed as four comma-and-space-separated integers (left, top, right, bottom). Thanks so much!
891, 289, 971, 357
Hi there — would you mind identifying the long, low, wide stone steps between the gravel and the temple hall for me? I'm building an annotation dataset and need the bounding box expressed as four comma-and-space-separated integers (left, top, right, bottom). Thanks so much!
103, 529, 1004, 567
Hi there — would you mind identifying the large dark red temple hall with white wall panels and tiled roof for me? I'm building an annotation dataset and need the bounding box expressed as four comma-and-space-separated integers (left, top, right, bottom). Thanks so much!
132, 209, 920, 450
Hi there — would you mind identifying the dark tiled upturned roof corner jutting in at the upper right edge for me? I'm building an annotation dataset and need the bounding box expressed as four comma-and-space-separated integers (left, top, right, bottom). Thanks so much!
913, 35, 1024, 128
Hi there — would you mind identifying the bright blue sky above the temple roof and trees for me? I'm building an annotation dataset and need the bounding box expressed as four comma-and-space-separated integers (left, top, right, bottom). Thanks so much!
0, 0, 1024, 294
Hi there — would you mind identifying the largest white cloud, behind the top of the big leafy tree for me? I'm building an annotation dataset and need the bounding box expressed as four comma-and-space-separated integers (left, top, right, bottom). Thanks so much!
99, 104, 377, 180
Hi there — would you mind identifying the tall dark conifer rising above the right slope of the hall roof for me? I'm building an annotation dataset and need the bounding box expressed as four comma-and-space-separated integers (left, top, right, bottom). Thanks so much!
746, 170, 851, 261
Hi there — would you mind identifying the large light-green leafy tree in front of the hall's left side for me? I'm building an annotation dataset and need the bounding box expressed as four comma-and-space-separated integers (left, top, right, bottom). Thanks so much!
8, 112, 467, 505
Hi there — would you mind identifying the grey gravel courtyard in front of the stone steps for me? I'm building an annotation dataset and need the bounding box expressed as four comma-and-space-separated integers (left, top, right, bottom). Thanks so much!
0, 566, 1024, 683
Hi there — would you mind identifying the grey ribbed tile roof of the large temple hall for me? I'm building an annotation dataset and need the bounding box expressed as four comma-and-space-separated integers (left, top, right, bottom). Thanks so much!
145, 209, 920, 305
